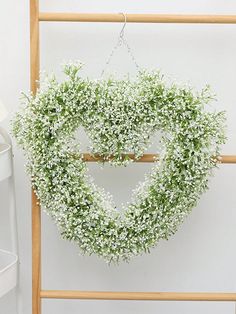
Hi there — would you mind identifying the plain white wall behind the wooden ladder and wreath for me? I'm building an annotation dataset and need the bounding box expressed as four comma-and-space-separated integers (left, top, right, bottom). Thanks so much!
0, 0, 236, 314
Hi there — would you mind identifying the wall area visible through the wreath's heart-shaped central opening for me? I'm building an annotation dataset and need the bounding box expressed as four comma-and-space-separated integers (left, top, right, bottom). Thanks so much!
75, 128, 161, 210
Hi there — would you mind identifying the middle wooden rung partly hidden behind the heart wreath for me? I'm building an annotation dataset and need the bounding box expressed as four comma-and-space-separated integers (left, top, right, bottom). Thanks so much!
80, 153, 236, 164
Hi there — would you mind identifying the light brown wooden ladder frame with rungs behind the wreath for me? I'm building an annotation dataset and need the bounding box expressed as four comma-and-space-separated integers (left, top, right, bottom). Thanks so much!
30, 0, 236, 314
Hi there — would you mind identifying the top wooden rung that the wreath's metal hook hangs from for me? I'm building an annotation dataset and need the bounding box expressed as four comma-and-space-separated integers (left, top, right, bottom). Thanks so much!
39, 12, 236, 24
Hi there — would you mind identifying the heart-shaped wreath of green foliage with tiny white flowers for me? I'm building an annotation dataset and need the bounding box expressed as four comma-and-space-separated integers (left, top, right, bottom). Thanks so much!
13, 63, 225, 262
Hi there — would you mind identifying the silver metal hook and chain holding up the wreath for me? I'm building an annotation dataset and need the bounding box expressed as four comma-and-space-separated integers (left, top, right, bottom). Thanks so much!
101, 13, 140, 77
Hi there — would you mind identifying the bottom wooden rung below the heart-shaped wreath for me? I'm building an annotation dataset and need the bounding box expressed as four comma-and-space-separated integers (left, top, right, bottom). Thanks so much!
40, 290, 236, 301
